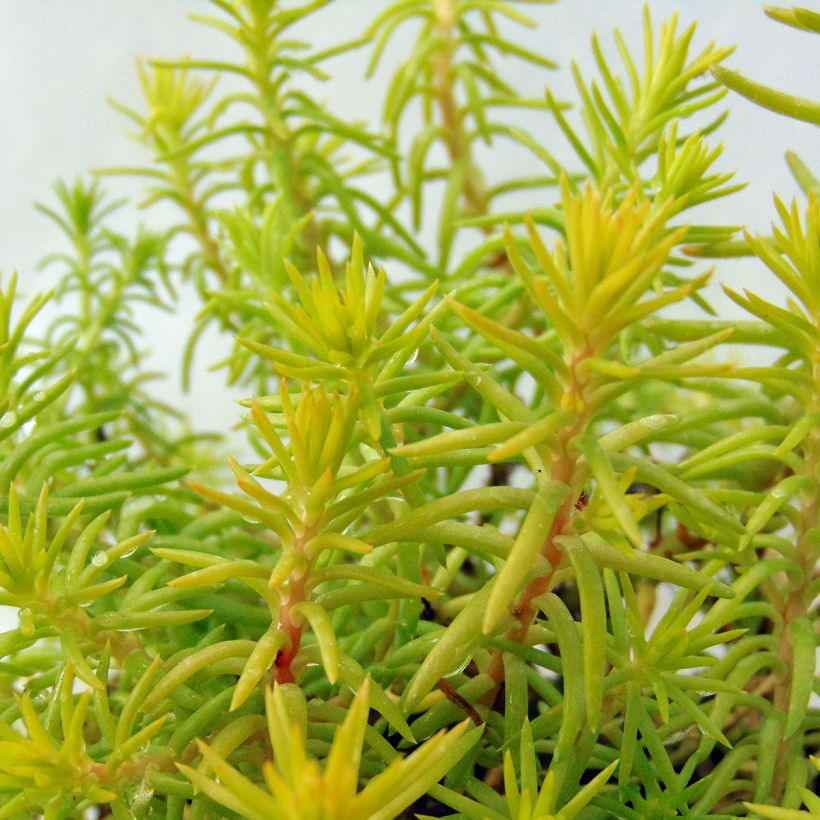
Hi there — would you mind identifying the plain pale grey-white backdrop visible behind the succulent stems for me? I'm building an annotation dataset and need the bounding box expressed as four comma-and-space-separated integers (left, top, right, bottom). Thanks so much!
0, 0, 820, 436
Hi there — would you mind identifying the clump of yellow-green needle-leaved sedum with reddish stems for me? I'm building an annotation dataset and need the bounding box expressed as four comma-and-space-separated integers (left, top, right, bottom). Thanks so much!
0, 0, 820, 820
